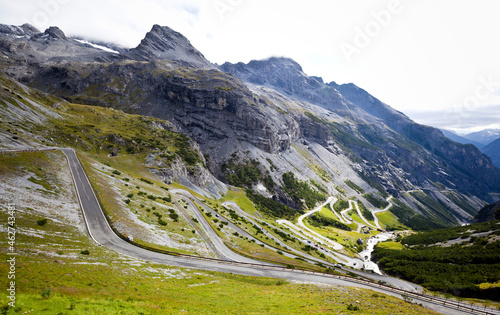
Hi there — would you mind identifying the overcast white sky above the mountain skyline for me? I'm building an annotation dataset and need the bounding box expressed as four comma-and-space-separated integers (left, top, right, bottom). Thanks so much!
0, 0, 500, 130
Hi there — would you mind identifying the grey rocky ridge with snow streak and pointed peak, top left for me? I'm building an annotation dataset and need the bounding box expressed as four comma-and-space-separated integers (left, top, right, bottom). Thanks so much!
0, 24, 216, 69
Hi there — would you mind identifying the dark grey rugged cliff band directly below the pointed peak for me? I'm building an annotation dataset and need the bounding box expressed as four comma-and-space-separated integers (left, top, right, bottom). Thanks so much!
26, 61, 297, 153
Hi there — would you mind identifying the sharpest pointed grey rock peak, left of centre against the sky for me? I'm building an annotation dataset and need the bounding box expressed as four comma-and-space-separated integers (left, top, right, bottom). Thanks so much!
129, 24, 214, 69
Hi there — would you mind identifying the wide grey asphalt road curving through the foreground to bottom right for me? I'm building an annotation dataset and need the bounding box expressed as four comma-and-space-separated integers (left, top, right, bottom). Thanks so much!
54, 149, 500, 315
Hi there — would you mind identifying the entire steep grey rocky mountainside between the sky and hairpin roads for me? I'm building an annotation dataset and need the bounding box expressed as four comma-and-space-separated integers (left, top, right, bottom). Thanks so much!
0, 25, 500, 227
